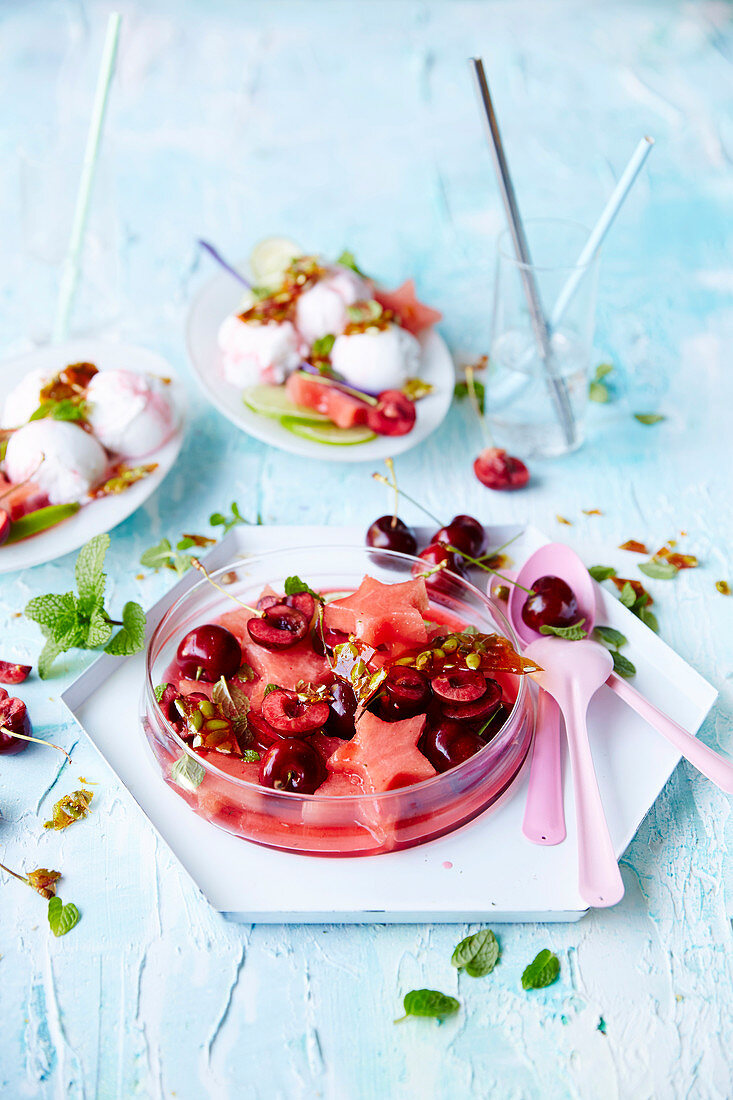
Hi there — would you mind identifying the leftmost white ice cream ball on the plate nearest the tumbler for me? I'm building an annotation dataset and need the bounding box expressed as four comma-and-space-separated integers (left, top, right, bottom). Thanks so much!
219, 314, 302, 386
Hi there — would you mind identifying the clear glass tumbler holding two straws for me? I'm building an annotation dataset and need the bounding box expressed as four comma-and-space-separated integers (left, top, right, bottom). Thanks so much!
484, 218, 599, 458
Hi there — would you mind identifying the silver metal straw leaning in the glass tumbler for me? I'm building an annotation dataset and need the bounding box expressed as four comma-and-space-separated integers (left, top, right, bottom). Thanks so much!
470, 57, 576, 446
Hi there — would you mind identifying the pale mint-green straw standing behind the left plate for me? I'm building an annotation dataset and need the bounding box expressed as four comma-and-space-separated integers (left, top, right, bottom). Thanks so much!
53, 11, 121, 342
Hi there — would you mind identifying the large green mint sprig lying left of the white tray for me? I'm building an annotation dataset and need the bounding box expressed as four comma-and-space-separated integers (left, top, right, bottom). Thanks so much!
25, 535, 145, 680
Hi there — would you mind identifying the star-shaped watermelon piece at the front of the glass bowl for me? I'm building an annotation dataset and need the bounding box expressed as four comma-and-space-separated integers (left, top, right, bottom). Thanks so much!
328, 711, 437, 794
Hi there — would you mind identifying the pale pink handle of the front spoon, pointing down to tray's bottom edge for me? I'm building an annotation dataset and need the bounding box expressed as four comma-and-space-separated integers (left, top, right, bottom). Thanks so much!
565, 692, 624, 908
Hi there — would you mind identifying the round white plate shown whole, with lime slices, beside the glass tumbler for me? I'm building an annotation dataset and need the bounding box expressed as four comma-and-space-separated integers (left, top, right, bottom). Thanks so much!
187, 265, 456, 462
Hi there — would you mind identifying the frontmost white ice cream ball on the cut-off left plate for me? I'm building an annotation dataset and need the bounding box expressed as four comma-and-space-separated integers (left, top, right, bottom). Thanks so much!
4, 419, 107, 504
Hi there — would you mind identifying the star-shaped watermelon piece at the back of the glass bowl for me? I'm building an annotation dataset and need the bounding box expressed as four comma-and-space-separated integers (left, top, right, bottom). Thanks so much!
325, 576, 428, 649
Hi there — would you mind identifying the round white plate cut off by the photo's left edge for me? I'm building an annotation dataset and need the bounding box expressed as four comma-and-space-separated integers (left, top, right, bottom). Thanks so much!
0, 340, 185, 573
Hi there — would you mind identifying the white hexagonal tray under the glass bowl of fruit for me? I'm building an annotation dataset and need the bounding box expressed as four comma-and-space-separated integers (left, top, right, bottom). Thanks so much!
62, 527, 716, 924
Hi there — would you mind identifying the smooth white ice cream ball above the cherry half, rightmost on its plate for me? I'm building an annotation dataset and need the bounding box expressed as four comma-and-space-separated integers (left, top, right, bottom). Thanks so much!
331, 325, 420, 394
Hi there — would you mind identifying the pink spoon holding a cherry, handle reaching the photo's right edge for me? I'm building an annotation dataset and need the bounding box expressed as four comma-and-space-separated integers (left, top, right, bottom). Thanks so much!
507, 542, 733, 792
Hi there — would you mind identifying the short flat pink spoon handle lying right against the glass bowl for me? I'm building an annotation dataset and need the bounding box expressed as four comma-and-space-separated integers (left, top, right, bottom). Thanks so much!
522, 689, 566, 844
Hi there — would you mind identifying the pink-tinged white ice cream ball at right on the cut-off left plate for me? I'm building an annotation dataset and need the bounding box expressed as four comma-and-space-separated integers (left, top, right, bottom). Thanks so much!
87, 371, 176, 459
